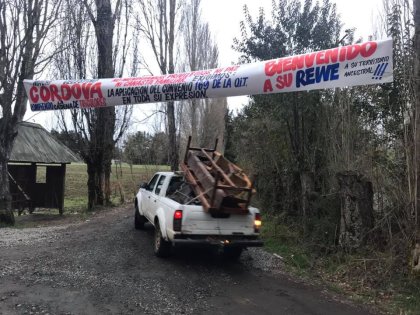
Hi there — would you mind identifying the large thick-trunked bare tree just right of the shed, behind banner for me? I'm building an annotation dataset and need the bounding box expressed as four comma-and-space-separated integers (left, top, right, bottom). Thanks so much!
55, 0, 133, 209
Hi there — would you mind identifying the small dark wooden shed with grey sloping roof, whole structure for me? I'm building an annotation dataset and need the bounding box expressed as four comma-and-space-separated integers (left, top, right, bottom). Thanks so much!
8, 122, 80, 214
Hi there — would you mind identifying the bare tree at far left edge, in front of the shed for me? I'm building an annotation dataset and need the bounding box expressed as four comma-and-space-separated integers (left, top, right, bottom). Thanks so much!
0, 0, 61, 224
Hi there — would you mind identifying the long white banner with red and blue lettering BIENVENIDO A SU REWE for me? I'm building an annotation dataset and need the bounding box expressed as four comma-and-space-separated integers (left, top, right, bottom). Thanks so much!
24, 39, 393, 111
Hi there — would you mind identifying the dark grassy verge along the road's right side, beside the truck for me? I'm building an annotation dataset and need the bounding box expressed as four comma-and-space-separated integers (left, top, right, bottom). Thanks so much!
261, 215, 420, 315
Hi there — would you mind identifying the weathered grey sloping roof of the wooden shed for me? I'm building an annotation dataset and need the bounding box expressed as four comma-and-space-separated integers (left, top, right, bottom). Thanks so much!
9, 122, 80, 164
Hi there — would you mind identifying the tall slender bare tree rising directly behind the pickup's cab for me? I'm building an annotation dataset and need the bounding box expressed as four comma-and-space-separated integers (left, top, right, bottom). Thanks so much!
139, 0, 180, 170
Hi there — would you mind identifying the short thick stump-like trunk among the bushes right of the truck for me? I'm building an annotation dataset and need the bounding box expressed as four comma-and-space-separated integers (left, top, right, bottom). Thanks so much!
336, 171, 374, 251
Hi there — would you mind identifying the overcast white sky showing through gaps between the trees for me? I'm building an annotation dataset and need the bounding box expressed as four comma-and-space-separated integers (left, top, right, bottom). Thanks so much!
25, 0, 383, 131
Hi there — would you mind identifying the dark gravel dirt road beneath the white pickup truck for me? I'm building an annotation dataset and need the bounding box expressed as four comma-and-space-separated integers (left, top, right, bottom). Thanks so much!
0, 207, 369, 314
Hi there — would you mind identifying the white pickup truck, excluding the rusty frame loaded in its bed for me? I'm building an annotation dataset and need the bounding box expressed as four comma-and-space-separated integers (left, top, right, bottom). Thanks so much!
134, 172, 263, 259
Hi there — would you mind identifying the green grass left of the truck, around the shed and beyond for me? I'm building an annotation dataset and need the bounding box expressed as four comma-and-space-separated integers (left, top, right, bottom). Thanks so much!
14, 163, 170, 228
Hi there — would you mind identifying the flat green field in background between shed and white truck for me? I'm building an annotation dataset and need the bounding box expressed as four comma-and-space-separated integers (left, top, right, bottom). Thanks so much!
64, 163, 169, 212
